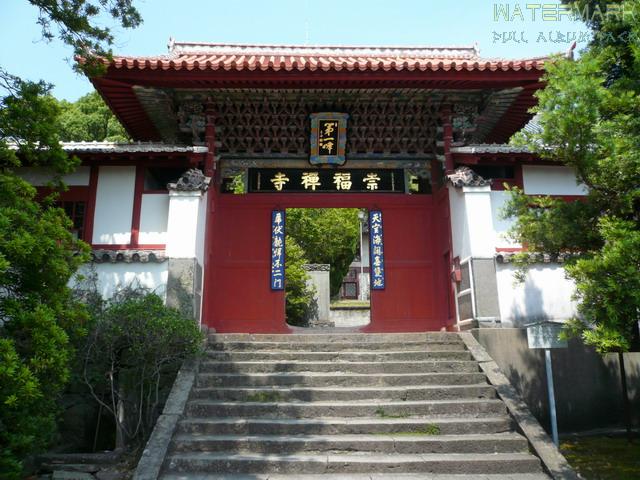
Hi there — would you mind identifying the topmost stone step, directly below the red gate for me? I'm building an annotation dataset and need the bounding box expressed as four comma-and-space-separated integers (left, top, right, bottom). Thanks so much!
208, 332, 462, 344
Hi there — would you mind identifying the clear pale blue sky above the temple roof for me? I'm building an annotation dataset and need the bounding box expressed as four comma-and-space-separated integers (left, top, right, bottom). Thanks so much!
0, 0, 588, 101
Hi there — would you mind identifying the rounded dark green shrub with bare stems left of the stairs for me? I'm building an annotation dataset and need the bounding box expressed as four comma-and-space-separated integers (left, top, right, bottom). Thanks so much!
82, 288, 203, 447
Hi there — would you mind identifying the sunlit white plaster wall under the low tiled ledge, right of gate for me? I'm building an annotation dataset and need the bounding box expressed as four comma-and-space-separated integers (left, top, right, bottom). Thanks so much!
496, 264, 577, 326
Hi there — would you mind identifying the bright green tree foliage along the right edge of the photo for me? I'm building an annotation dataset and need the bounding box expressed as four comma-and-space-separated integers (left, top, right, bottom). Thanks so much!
506, 0, 640, 352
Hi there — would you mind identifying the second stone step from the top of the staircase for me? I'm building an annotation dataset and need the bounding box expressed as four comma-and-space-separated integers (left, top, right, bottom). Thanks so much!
207, 350, 473, 362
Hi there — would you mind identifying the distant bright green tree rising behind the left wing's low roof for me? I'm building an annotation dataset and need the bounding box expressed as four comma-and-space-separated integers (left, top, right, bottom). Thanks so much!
59, 92, 128, 142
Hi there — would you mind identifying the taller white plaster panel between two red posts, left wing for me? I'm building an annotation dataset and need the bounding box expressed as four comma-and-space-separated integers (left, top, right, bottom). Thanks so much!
93, 166, 136, 245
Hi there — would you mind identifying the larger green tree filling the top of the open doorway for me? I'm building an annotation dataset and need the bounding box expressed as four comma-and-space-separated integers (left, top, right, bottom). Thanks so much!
287, 208, 359, 297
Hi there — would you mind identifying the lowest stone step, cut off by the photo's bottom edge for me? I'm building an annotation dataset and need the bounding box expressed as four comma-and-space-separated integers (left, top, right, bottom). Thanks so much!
159, 473, 549, 480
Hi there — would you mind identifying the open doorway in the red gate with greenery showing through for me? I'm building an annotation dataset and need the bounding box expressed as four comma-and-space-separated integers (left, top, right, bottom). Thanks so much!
285, 208, 371, 328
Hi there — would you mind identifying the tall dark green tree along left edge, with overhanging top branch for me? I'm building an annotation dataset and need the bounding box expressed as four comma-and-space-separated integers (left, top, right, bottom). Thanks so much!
0, 0, 140, 479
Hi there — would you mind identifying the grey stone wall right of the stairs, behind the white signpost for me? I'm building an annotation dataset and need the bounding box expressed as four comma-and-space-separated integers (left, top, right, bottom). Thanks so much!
472, 328, 640, 433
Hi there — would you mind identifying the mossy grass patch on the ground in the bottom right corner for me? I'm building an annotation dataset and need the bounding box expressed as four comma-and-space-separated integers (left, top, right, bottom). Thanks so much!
560, 436, 640, 480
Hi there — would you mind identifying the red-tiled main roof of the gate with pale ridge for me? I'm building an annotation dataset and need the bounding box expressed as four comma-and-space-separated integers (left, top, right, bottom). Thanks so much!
111, 40, 544, 71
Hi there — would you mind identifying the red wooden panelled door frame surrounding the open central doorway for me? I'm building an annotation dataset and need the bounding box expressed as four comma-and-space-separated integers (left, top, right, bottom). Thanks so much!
202, 191, 451, 333
